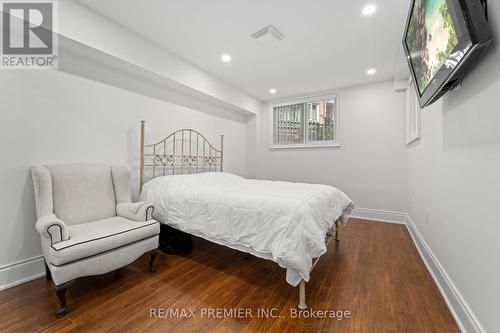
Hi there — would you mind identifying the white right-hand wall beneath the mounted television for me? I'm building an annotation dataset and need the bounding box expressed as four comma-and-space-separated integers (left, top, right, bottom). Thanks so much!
408, 1, 500, 332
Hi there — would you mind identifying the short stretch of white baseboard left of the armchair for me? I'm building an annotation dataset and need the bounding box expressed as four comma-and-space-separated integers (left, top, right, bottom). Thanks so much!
0, 256, 45, 290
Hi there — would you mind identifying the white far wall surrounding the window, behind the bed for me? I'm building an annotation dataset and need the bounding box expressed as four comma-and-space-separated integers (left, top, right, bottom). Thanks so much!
251, 82, 407, 213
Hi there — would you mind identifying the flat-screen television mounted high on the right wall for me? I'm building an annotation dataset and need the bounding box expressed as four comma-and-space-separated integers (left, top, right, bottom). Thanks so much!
403, 0, 491, 108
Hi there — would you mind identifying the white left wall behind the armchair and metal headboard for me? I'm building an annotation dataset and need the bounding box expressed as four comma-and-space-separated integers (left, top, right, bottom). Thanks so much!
0, 70, 247, 288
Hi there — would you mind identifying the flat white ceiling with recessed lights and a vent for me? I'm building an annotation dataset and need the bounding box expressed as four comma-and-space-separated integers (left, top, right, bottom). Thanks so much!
80, 0, 408, 101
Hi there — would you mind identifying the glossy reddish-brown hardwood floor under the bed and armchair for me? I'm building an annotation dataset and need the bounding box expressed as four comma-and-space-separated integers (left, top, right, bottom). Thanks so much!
0, 219, 459, 332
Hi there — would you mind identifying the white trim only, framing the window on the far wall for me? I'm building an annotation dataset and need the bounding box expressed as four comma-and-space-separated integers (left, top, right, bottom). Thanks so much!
269, 91, 341, 149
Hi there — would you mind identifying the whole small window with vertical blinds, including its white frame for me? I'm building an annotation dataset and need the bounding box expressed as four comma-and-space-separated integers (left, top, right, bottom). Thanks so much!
270, 94, 339, 149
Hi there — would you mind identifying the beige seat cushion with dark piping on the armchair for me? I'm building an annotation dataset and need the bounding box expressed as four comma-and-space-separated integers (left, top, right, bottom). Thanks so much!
49, 216, 160, 266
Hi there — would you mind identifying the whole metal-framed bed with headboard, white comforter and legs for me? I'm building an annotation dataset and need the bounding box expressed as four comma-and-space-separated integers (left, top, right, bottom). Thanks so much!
140, 121, 353, 309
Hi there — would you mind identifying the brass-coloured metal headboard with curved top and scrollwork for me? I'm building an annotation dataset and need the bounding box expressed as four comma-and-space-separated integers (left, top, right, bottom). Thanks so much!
140, 120, 224, 189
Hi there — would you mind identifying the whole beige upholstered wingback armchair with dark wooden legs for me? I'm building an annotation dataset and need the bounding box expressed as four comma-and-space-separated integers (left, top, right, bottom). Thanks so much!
31, 164, 160, 317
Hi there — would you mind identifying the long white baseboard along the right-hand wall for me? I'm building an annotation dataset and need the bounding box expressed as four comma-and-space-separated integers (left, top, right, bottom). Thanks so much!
406, 215, 485, 333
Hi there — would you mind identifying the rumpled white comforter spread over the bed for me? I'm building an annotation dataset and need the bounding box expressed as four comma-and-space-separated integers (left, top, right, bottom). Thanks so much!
141, 172, 353, 286
